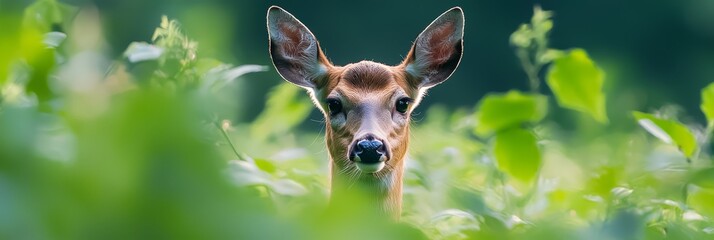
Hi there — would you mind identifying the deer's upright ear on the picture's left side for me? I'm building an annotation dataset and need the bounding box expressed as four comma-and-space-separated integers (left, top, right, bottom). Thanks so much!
267, 6, 332, 89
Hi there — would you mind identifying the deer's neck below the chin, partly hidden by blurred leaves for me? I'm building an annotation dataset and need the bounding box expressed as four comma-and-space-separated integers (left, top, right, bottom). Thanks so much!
330, 159, 404, 220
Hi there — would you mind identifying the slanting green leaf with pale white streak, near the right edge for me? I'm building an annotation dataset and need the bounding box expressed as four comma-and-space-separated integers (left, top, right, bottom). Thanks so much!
632, 112, 697, 157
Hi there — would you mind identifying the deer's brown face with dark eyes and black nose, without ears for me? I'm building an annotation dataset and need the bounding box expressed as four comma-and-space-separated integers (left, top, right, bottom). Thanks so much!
315, 61, 419, 173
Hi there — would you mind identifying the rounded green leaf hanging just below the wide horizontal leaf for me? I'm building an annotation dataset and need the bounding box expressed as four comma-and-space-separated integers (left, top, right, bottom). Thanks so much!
493, 128, 541, 182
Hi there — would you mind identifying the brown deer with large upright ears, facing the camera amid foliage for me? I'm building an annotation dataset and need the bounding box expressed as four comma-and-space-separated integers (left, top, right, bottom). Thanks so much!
267, 6, 464, 221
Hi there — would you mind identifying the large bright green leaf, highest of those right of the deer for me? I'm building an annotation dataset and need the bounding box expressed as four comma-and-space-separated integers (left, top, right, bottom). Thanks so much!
547, 49, 607, 123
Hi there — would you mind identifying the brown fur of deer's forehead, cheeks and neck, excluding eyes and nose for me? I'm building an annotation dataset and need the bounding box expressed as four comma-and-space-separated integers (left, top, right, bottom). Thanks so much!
318, 61, 419, 219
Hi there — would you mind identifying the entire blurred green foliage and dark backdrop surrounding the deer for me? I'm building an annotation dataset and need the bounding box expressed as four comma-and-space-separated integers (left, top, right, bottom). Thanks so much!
0, 0, 714, 239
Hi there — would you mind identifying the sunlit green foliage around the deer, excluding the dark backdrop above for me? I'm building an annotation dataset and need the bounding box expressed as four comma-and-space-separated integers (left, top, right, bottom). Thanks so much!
0, 0, 714, 239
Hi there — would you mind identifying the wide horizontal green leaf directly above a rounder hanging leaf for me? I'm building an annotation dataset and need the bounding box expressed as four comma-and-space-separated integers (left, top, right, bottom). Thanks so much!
474, 91, 548, 136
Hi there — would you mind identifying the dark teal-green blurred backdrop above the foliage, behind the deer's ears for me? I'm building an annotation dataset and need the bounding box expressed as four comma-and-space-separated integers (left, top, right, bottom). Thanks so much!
40, 0, 714, 124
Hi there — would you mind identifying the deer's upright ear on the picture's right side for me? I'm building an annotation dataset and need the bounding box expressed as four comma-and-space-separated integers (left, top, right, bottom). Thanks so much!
402, 7, 464, 88
